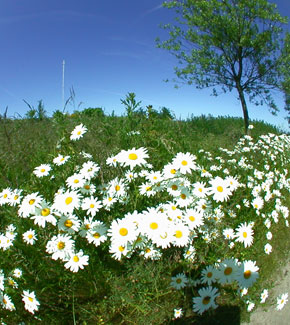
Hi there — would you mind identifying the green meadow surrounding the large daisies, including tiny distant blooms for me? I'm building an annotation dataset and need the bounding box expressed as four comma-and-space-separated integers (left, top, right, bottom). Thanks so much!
0, 107, 290, 325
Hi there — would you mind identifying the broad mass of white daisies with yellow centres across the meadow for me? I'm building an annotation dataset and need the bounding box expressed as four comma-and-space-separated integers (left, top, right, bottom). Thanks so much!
0, 124, 290, 313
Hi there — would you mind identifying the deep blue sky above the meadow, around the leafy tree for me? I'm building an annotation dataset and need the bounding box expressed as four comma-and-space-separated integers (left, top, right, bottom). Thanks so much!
0, 0, 290, 130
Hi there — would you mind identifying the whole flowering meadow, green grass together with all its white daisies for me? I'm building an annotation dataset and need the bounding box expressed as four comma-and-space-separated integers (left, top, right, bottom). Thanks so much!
0, 105, 290, 324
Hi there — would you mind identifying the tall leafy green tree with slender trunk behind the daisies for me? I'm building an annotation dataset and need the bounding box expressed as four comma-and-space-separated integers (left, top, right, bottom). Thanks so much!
156, 0, 289, 133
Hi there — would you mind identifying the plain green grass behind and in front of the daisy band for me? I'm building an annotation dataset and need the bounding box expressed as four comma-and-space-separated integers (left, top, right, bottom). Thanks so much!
0, 105, 290, 324
